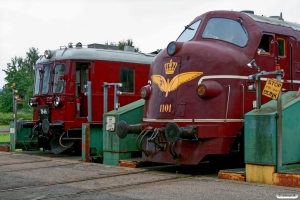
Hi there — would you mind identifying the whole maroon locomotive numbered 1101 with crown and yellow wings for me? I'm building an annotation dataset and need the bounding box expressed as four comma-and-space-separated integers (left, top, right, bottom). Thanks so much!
117, 11, 300, 165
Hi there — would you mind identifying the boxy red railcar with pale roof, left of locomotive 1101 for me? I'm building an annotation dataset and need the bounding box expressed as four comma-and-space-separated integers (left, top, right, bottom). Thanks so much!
17, 43, 154, 153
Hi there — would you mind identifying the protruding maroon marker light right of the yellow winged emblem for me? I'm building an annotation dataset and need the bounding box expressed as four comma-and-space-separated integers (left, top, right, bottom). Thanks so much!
196, 81, 223, 99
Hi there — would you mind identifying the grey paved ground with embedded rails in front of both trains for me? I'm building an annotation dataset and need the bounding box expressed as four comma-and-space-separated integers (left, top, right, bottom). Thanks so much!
0, 152, 300, 200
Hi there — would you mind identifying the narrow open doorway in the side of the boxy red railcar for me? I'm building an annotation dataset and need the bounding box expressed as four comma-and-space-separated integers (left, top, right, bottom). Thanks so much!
75, 62, 91, 117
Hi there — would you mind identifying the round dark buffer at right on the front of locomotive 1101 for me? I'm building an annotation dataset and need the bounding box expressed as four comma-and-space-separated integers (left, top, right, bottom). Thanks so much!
165, 122, 197, 143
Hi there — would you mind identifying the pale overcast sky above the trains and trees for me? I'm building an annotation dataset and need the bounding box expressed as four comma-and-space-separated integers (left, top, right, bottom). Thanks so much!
0, 0, 300, 88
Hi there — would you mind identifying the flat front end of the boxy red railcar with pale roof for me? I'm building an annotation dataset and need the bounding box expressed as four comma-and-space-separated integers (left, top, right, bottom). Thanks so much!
17, 49, 80, 154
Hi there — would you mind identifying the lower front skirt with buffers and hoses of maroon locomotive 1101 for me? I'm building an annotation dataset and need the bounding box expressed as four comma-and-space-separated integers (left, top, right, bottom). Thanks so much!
117, 121, 243, 165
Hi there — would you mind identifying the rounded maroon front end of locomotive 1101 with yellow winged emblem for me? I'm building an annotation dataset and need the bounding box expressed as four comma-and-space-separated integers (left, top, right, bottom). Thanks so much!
117, 12, 254, 165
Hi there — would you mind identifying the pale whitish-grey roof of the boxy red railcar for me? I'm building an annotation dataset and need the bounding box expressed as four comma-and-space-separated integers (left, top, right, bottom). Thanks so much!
36, 47, 155, 64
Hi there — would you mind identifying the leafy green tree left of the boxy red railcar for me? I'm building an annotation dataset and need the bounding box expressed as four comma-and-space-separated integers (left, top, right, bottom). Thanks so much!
0, 47, 39, 112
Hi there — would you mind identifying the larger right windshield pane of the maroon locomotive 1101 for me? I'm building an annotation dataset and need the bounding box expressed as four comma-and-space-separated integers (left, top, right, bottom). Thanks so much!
202, 18, 248, 47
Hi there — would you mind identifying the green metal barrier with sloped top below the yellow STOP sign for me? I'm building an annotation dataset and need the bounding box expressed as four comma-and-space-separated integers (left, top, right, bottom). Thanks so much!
245, 92, 300, 171
